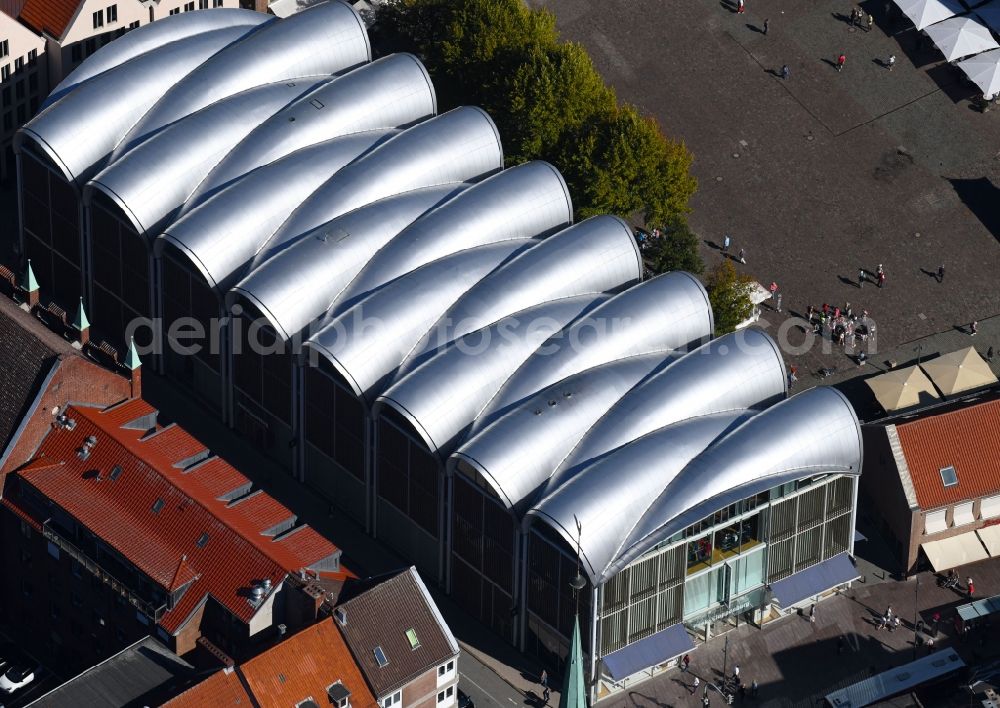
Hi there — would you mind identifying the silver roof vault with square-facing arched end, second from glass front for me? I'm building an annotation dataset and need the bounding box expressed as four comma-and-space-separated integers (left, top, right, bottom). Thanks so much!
548, 329, 788, 489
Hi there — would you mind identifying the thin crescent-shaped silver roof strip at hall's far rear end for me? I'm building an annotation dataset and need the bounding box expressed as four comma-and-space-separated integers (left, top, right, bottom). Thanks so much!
42, 8, 275, 110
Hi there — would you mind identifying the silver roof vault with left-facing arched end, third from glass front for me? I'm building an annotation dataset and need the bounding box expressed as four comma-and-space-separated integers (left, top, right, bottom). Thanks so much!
373, 294, 608, 457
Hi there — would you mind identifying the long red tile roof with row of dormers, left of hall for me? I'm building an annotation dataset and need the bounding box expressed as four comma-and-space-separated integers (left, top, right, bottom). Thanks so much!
7, 400, 337, 633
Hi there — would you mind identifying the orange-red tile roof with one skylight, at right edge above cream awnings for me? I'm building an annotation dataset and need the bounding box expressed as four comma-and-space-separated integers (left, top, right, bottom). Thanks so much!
896, 401, 1000, 509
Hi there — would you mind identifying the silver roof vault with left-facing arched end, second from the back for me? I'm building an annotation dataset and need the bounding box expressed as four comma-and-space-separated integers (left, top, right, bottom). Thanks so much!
84, 80, 324, 238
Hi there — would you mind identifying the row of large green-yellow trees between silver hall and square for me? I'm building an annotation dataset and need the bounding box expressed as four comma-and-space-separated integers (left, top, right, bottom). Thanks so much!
374, 0, 700, 232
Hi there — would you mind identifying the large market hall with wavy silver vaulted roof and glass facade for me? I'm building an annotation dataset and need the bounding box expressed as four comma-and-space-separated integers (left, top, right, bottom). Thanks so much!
16, 2, 862, 692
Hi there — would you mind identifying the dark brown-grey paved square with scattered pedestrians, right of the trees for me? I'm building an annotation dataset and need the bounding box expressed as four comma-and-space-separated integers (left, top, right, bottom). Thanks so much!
529, 0, 1000, 368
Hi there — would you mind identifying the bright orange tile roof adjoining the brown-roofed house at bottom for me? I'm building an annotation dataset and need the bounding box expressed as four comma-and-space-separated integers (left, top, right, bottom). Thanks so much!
239, 618, 375, 708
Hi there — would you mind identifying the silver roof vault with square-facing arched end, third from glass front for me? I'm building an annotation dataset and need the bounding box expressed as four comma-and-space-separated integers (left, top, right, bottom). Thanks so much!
473, 271, 713, 431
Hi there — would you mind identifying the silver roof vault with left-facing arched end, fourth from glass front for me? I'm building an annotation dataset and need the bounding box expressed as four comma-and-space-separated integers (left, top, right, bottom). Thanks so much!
306, 239, 535, 405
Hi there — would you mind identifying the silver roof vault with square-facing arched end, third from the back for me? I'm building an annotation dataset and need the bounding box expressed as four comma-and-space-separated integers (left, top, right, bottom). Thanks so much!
268, 106, 503, 256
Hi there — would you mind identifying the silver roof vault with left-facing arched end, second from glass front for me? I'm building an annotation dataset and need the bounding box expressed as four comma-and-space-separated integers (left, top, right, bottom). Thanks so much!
449, 352, 672, 508
